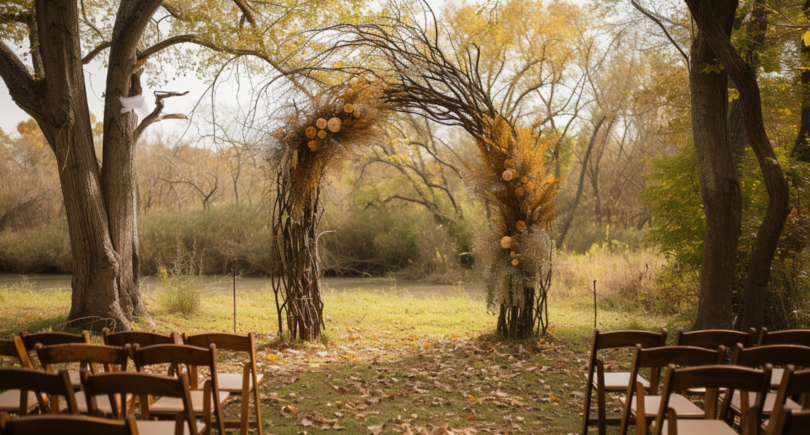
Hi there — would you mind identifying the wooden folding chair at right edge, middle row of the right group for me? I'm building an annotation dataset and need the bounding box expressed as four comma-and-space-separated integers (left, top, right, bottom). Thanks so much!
731, 344, 810, 416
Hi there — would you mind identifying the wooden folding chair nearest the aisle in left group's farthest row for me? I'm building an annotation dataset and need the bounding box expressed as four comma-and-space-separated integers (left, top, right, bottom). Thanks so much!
183, 332, 264, 435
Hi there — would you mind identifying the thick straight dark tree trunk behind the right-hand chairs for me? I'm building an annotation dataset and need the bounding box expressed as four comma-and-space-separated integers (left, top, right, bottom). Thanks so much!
689, 0, 742, 328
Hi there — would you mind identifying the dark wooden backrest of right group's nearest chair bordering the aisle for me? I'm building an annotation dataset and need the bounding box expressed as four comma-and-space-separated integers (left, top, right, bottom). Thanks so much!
655, 364, 771, 435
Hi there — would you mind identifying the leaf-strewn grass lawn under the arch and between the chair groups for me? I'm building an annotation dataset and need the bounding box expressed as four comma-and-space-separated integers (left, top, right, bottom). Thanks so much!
0, 279, 668, 434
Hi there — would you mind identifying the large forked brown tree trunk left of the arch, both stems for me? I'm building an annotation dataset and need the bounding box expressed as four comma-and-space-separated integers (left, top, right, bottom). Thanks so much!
0, 0, 166, 329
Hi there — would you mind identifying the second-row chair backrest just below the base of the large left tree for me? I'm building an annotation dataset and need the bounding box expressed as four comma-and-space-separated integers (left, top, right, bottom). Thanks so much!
36, 343, 129, 373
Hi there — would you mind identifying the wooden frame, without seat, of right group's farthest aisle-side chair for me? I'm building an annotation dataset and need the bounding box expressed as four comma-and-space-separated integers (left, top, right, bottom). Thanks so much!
582, 329, 667, 435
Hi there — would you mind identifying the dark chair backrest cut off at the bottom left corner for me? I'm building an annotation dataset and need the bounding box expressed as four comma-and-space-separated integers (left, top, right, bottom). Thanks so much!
0, 415, 138, 435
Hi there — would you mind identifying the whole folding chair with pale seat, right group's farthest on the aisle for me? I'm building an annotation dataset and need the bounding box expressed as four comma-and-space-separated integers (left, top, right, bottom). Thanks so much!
582, 330, 667, 435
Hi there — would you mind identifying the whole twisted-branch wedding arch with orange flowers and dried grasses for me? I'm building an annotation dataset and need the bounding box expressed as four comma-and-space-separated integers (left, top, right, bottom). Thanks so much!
272, 8, 557, 340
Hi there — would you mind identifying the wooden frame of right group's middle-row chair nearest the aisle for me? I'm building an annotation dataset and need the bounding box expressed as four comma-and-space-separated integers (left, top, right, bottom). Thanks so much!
619, 345, 726, 435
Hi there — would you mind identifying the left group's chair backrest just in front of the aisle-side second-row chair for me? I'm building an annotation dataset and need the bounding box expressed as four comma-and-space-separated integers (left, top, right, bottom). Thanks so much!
82, 372, 197, 434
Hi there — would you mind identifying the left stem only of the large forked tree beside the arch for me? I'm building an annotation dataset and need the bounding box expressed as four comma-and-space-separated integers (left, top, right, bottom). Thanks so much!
36, 1, 131, 328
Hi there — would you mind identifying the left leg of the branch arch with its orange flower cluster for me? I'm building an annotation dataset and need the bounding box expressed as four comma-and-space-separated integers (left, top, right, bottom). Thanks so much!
271, 77, 388, 340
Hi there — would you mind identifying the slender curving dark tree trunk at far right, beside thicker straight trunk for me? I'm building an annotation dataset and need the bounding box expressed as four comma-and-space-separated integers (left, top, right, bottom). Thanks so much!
688, 0, 789, 328
